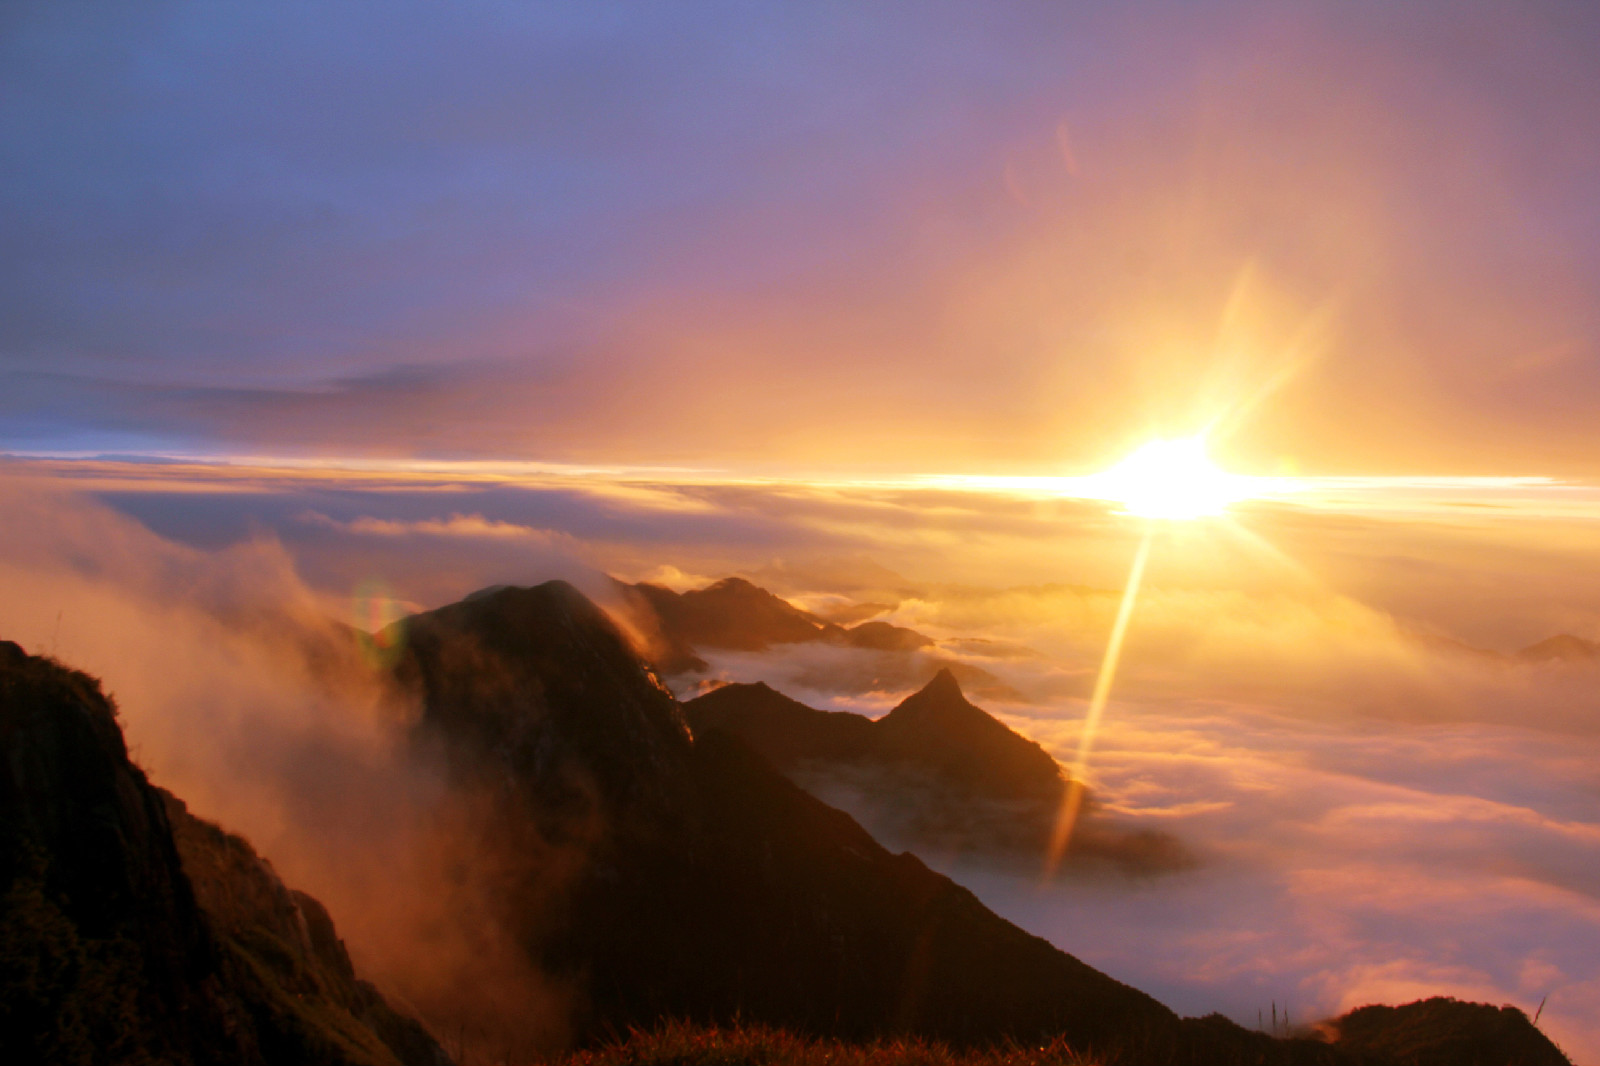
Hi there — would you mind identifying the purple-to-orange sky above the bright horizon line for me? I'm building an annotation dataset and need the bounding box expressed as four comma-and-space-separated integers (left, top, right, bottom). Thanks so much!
9, 3, 1600, 475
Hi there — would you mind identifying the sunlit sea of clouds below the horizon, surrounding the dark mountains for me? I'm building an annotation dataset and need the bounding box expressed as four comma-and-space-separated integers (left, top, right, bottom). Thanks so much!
0, 460, 1600, 1060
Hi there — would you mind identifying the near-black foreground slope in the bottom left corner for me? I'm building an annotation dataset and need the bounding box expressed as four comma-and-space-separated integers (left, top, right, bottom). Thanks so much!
0, 642, 448, 1066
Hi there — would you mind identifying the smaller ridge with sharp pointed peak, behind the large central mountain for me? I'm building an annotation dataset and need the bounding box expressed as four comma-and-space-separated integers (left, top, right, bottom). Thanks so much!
685, 671, 1194, 874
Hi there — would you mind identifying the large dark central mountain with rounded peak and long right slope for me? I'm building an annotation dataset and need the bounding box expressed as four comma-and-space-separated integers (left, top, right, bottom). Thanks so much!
387, 583, 1203, 1042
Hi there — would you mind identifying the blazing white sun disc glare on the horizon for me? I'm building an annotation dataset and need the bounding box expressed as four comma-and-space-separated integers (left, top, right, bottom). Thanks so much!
1085, 437, 1262, 519
